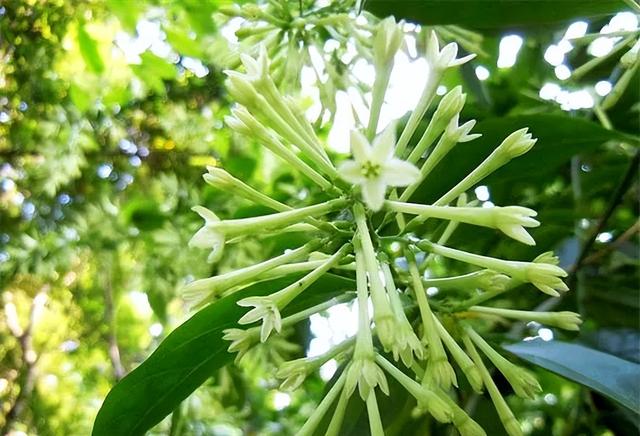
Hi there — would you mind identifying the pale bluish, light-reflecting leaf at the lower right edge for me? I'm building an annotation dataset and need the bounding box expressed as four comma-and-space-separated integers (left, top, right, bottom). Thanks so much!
504, 339, 640, 413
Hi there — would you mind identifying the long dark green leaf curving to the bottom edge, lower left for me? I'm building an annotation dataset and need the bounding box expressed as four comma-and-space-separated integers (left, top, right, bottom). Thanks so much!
92, 274, 354, 436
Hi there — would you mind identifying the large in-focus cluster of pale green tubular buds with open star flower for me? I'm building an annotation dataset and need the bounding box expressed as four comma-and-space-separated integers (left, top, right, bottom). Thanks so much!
184, 13, 580, 436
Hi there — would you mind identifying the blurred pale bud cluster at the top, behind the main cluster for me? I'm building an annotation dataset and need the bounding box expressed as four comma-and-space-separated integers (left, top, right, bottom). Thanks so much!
218, 0, 486, 124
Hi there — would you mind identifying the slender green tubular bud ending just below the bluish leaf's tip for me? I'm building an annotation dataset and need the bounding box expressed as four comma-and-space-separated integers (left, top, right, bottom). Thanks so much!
465, 325, 542, 398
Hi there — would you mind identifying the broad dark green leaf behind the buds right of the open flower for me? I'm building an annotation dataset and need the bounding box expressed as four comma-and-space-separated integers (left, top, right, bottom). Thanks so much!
412, 114, 637, 203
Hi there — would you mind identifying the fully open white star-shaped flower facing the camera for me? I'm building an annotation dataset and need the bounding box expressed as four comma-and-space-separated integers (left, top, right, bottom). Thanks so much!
338, 124, 420, 211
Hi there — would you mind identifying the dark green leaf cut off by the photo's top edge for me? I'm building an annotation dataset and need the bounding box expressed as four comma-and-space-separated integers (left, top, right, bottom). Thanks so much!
364, 0, 625, 29
